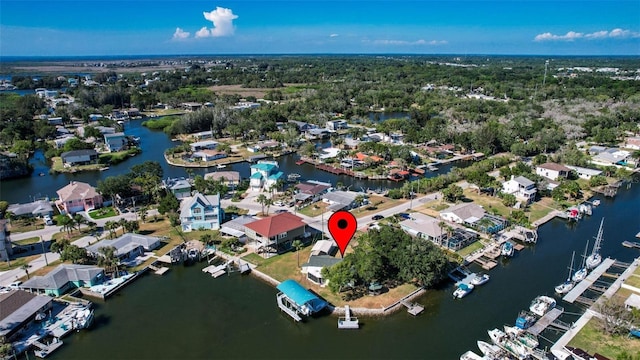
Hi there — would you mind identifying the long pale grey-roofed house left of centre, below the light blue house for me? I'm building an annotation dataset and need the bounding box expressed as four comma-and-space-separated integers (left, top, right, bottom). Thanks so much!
87, 233, 160, 260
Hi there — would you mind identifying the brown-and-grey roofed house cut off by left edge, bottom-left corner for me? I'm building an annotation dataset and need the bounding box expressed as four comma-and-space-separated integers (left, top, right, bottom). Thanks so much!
0, 290, 53, 344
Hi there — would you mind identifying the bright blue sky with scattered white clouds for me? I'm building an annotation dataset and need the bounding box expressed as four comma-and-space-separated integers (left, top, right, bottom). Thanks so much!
0, 0, 640, 56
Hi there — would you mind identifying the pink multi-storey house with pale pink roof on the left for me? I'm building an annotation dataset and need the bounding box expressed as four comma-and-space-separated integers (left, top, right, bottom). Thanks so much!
55, 181, 103, 214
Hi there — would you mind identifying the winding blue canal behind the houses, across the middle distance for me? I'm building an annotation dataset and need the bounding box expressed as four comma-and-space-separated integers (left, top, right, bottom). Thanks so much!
0, 120, 462, 203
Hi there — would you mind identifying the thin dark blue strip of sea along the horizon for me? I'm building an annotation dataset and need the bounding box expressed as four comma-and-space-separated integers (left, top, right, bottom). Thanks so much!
0, 53, 640, 63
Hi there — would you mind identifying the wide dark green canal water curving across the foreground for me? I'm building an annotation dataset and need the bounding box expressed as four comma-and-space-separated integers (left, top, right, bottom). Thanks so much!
46, 183, 640, 359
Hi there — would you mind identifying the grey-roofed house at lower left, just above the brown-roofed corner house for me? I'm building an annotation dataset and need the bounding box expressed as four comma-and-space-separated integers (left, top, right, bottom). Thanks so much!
20, 264, 105, 296
